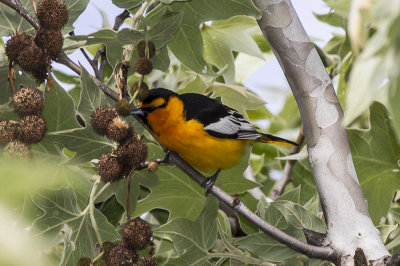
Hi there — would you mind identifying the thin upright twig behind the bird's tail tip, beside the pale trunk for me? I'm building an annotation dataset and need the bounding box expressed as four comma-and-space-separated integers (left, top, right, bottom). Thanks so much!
271, 125, 304, 200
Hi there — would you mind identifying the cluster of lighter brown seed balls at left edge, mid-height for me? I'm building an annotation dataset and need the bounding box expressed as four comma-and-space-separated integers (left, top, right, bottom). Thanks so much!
0, 87, 47, 158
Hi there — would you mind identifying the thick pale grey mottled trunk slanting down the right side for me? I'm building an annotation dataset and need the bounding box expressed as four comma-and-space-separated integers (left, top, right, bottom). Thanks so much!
253, 0, 389, 264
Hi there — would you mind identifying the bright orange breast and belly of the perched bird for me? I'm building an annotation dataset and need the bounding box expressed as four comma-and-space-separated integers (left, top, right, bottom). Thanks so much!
147, 97, 247, 171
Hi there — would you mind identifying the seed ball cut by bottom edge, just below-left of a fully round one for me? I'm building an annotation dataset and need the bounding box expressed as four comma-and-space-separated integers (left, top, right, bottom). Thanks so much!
106, 243, 138, 266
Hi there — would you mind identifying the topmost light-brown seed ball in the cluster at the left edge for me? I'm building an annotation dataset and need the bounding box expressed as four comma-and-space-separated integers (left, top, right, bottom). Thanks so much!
12, 88, 43, 116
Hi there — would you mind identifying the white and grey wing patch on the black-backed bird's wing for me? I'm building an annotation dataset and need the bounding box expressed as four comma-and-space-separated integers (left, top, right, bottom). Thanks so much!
204, 110, 261, 140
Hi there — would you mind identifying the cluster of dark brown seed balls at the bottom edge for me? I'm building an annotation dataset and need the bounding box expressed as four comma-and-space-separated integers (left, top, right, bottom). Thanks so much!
102, 218, 158, 266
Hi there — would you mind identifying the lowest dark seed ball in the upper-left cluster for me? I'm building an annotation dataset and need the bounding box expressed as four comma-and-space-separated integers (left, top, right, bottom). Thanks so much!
15, 42, 50, 83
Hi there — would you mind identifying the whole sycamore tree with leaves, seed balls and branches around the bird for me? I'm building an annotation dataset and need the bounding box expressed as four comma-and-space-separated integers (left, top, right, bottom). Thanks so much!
0, 0, 400, 265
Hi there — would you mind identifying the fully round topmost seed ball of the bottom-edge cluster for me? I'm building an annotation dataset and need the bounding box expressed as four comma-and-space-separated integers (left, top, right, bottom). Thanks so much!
122, 218, 153, 250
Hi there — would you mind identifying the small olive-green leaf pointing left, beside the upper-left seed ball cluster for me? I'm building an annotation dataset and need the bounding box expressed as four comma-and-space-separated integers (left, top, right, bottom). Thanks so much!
68, 29, 123, 66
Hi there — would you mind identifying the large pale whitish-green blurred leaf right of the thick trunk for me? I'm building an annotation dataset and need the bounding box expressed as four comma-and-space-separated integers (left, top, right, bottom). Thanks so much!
344, 10, 400, 125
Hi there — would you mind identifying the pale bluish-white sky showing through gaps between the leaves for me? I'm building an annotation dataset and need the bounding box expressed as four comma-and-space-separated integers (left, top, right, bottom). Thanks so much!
53, 0, 340, 113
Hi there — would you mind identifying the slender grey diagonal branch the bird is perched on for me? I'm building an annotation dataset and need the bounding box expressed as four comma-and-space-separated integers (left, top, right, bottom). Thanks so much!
0, 0, 337, 261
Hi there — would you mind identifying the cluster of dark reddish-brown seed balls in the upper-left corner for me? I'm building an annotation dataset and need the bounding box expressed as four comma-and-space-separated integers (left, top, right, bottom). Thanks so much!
6, 0, 68, 83
